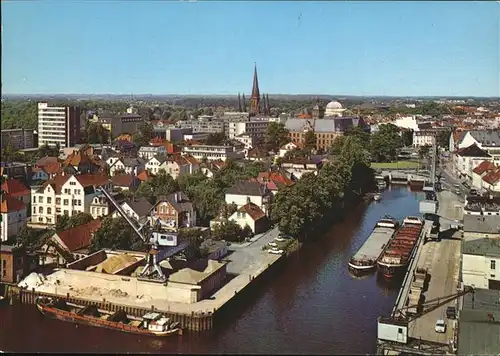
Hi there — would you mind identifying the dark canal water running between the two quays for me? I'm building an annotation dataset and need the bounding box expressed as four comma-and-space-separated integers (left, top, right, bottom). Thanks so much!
0, 187, 421, 354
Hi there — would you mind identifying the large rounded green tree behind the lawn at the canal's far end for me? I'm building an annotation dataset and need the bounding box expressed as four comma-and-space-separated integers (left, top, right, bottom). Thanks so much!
371, 124, 403, 162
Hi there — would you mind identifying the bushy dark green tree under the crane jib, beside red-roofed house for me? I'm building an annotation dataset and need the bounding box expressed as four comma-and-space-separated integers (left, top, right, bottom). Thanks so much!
90, 215, 147, 252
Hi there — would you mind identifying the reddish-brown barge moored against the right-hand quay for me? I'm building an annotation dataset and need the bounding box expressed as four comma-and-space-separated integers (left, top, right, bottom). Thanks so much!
377, 216, 424, 278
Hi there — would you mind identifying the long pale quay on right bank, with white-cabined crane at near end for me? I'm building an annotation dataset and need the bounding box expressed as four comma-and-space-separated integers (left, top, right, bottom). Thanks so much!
377, 191, 468, 355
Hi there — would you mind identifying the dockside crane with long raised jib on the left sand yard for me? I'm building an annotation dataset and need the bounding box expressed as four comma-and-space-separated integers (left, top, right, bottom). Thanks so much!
97, 187, 170, 282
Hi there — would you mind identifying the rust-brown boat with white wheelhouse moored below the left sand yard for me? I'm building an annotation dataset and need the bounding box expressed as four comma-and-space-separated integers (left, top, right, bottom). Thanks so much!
36, 297, 182, 336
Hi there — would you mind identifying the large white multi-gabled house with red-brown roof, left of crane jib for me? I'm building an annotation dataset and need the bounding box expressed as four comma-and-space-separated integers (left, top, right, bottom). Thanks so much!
31, 174, 111, 225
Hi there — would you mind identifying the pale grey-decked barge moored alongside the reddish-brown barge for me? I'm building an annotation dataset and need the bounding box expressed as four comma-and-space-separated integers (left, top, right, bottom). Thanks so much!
349, 217, 399, 272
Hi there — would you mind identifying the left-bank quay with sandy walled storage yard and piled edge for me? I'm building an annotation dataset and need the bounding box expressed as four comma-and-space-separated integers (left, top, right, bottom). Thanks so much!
2, 229, 285, 331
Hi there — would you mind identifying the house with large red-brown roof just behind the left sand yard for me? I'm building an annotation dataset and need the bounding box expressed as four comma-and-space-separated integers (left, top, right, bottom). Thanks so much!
39, 219, 101, 266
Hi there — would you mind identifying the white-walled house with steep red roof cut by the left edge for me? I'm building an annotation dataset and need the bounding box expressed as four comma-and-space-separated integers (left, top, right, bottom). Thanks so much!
0, 193, 27, 242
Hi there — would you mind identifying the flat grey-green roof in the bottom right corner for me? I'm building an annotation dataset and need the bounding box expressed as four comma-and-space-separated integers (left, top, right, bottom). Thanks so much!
458, 289, 500, 355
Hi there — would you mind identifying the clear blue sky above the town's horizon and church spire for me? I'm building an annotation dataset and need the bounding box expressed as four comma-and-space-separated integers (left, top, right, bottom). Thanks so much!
2, 0, 500, 96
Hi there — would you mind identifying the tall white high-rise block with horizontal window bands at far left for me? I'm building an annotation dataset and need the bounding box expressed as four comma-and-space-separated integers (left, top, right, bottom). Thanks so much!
38, 103, 81, 148
